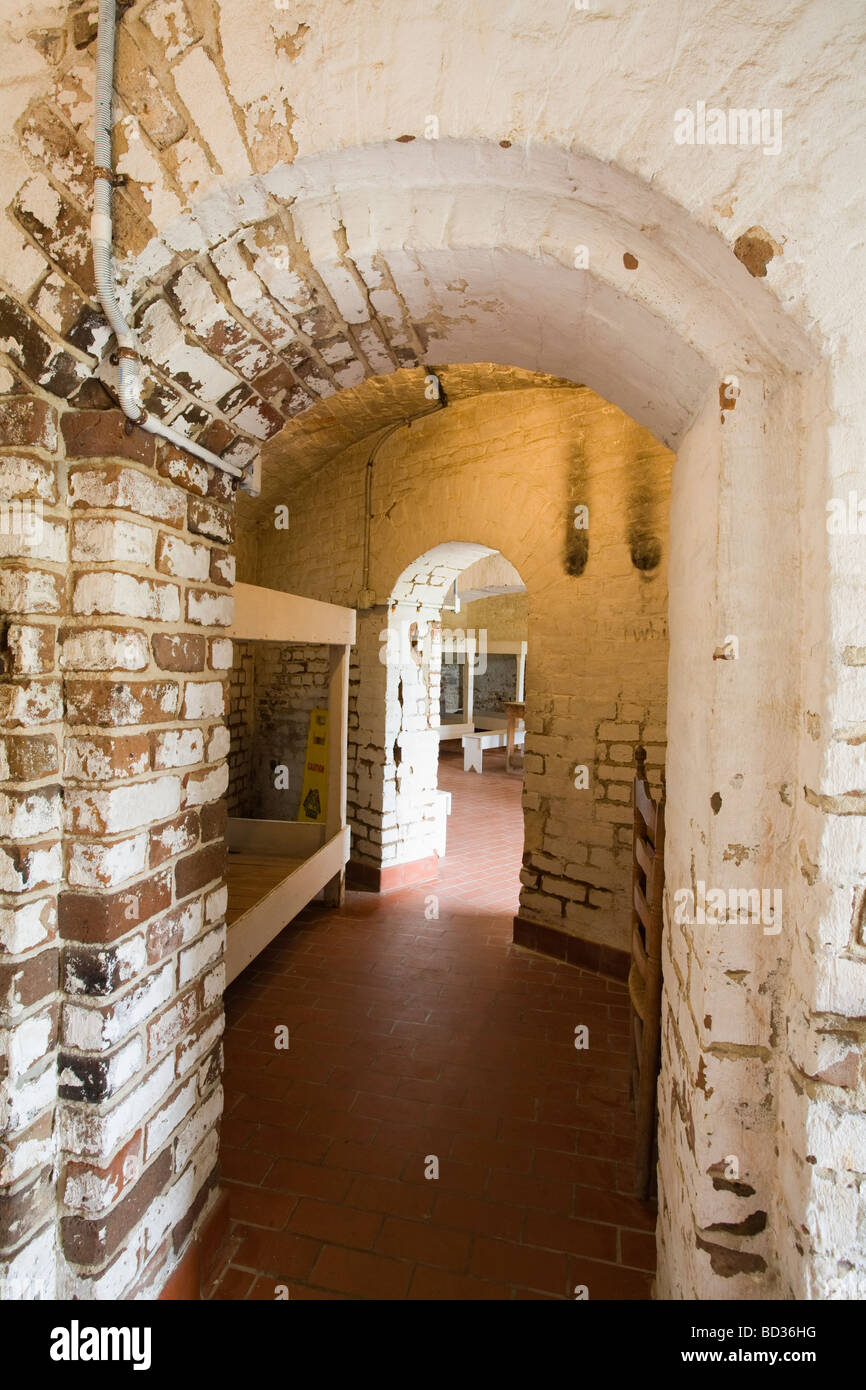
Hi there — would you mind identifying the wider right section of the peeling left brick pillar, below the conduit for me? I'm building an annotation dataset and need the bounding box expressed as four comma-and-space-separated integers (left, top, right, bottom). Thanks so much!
57, 410, 234, 1298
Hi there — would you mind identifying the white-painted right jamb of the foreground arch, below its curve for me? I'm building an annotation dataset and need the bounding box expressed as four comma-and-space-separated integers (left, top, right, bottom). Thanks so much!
656, 374, 803, 1300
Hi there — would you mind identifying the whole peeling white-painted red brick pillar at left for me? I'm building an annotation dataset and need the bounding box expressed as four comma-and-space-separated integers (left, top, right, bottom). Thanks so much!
0, 377, 234, 1298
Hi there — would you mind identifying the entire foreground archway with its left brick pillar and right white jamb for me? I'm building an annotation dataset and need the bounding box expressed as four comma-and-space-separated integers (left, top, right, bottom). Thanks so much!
3, 27, 862, 1297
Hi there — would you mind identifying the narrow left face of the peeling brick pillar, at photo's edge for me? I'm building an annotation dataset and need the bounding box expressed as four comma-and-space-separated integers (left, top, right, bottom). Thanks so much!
0, 393, 67, 1300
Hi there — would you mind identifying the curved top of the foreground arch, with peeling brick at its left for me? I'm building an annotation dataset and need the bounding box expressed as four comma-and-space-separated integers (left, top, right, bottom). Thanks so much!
0, 4, 808, 530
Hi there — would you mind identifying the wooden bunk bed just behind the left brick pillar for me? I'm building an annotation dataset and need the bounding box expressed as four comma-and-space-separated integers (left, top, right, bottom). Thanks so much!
225, 584, 354, 984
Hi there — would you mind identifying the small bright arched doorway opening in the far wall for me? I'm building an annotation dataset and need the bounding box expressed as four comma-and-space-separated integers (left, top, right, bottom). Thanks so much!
384, 541, 528, 916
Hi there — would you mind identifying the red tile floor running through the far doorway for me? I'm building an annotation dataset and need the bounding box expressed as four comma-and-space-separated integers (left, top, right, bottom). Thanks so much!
210, 751, 655, 1300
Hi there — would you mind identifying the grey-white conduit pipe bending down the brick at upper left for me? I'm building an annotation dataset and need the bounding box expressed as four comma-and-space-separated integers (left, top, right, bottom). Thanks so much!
90, 0, 243, 478
